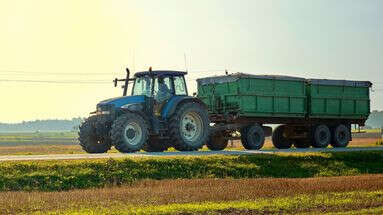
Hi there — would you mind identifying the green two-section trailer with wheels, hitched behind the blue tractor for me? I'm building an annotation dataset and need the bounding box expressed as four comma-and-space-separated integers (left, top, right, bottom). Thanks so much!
197, 73, 371, 150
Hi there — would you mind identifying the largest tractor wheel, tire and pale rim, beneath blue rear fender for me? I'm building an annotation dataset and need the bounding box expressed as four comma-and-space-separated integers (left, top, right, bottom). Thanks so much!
169, 102, 209, 151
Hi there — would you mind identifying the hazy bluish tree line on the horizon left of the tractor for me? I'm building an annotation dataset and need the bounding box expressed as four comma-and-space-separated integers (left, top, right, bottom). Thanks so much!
0, 117, 83, 132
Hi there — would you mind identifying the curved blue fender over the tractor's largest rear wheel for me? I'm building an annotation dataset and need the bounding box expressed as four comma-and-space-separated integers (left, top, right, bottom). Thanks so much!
161, 96, 207, 119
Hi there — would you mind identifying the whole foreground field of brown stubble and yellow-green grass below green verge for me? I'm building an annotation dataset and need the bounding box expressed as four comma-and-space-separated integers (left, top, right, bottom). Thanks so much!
0, 174, 383, 214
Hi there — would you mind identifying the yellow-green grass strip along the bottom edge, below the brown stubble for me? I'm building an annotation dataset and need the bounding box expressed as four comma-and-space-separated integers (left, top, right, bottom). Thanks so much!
38, 191, 383, 214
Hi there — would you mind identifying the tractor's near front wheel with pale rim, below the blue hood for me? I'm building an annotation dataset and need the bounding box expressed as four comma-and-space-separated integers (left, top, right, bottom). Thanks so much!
111, 113, 149, 153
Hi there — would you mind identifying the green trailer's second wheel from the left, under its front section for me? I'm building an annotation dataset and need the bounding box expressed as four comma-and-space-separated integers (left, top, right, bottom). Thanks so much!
241, 124, 265, 150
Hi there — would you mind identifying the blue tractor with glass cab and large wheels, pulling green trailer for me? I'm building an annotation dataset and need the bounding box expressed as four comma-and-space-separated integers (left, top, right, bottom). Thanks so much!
79, 69, 209, 153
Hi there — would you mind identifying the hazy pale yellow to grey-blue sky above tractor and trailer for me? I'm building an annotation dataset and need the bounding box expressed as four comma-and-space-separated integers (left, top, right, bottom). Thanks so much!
0, 0, 383, 122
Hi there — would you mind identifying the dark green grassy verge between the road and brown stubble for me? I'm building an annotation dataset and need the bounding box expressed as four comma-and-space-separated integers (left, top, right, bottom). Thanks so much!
0, 151, 383, 191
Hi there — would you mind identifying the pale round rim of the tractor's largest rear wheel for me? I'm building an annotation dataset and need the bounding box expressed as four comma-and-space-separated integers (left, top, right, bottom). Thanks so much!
181, 112, 202, 142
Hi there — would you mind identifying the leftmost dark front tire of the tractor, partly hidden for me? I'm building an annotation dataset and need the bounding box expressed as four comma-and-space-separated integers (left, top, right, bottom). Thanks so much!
78, 116, 112, 153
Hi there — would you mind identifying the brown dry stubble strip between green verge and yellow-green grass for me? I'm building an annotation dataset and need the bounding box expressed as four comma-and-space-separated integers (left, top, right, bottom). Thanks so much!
0, 174, 383, 214
